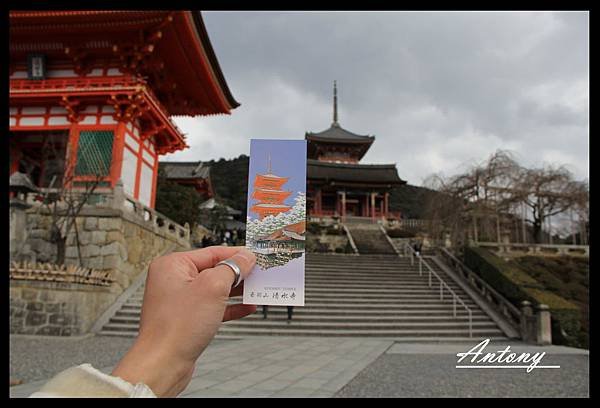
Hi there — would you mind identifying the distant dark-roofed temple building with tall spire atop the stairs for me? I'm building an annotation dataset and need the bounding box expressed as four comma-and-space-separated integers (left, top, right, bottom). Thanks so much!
305, 82, 406, 220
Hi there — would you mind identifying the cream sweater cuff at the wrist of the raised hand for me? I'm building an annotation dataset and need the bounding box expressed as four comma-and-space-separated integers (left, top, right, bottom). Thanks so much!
30, 364, 156, 398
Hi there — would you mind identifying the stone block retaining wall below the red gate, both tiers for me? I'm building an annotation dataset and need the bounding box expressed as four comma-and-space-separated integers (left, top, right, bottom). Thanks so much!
10, 183, 191, 335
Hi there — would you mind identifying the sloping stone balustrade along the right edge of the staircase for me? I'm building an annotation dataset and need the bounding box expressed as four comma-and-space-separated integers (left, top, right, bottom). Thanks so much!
439, 248, 521, 327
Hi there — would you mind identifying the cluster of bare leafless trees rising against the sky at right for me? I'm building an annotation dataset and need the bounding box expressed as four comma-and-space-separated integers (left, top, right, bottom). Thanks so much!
425, 150, 589, 245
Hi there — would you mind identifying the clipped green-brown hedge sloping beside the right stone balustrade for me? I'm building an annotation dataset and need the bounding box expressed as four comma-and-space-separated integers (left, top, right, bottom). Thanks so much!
464, 247, 581, 346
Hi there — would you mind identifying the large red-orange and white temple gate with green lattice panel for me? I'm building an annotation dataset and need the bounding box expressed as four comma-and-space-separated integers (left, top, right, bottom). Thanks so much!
9, 10, 239, 208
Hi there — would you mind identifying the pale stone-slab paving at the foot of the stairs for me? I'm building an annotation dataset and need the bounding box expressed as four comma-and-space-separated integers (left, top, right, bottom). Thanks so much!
10, 337, 393, 398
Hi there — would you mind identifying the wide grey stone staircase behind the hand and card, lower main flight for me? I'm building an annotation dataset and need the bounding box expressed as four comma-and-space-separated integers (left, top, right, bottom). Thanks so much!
100, 253, 506, 342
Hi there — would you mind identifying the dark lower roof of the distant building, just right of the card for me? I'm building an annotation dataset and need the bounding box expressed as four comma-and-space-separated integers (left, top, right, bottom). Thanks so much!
307, 159, 406, 185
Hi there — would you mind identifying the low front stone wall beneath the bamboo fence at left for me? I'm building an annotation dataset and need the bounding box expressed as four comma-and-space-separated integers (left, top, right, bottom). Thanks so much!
10, 280, 116, 336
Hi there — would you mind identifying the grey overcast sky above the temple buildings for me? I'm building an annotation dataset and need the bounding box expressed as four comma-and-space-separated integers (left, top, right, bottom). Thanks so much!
165, 12, 589, 185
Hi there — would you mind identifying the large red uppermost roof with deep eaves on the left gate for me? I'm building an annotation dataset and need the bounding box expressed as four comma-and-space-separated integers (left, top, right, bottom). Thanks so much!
9, 10, 239, 116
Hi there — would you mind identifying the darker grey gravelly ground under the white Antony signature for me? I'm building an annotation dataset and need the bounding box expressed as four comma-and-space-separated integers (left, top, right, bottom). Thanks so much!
337, 343, 589, 397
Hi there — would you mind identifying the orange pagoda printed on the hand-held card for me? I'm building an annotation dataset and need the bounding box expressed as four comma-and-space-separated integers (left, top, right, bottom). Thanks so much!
250, 156, 292, 220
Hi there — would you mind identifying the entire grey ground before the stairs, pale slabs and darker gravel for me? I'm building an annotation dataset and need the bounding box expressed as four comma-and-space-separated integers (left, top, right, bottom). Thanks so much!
10, 337, 589, 398
